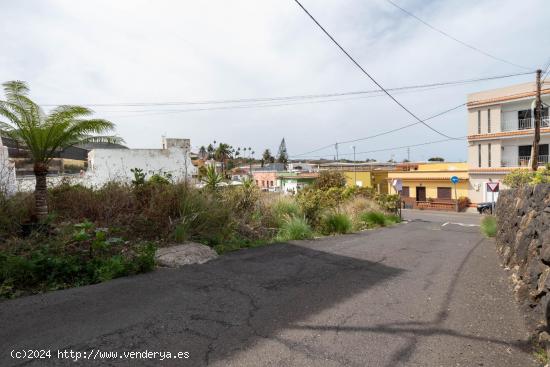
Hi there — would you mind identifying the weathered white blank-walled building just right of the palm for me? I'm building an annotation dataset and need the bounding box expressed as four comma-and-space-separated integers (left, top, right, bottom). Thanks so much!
86, 138, 197, 186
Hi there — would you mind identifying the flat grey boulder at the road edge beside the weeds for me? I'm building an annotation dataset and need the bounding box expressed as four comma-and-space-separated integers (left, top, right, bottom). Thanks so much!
155, 242, 218, 268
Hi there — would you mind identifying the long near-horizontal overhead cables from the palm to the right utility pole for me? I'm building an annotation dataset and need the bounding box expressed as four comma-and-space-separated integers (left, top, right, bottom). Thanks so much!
41, 72, 532, 107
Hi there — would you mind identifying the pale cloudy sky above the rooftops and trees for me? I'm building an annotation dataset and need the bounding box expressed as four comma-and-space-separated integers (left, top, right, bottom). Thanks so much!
0, 0, 550, 161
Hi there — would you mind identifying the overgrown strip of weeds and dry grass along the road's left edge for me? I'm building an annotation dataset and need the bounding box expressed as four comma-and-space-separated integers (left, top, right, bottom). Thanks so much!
0, 169, 406, 297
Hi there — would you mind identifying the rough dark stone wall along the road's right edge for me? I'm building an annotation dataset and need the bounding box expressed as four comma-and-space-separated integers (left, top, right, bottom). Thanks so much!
496, 184, 550, 345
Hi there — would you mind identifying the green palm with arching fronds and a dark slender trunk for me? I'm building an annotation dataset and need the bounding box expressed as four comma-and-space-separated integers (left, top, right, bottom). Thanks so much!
0, 81, 122, 220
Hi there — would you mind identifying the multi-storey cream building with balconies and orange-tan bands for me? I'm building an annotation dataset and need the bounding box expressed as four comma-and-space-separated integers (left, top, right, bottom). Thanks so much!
467, 80, 550, 203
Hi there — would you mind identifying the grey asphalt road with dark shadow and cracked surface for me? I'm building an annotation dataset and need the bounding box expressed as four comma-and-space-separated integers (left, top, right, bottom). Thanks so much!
0, 213, 537, 367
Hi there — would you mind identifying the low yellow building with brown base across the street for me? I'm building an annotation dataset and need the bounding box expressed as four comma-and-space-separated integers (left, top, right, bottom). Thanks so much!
387, 162, 469, 209
